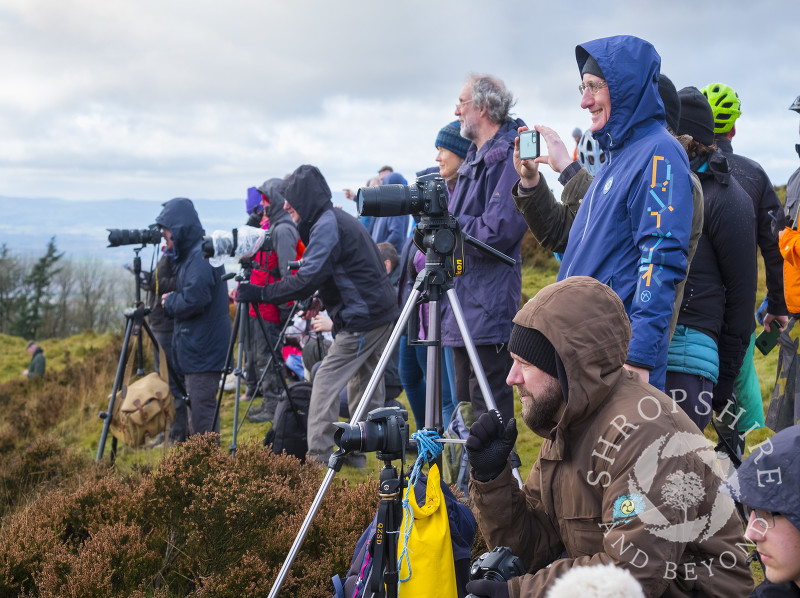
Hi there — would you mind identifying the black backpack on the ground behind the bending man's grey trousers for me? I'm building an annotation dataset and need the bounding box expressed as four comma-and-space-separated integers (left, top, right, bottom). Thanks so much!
264, 381, 311, 461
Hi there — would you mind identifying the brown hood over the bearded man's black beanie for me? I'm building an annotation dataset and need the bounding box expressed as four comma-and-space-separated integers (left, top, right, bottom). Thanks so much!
514, 276, 631, 438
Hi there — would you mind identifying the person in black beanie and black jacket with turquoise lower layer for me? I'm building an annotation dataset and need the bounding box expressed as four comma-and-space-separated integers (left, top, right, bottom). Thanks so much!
666, 87, 763, 444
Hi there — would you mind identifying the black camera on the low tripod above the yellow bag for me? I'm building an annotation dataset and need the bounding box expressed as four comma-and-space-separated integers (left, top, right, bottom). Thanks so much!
333, 407, 408, 460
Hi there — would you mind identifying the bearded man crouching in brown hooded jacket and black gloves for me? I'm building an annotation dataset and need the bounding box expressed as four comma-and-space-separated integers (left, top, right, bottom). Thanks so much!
466, 276, 753, 598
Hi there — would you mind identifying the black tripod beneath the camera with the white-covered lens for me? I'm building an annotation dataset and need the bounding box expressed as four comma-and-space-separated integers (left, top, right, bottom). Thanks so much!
212, 259, 303, 457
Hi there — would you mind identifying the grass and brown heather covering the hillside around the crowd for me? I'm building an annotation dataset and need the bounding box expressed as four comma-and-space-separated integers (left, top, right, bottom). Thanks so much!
0, 248, 777, 597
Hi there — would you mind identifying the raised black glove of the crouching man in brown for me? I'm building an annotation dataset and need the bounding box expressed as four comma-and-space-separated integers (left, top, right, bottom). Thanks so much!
466, 409, 517, 482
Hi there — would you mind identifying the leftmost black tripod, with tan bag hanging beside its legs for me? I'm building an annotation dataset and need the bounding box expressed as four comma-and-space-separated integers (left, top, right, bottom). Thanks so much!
95, 245, 177, 462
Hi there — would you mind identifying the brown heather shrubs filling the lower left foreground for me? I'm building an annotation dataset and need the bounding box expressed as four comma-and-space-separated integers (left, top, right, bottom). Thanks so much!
0, 418, 476, 598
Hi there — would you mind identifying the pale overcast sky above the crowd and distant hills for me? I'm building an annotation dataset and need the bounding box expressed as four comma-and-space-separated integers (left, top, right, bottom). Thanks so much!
0, 0, 800, 206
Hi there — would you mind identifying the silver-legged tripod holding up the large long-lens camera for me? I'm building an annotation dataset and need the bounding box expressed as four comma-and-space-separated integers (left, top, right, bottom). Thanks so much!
269, 200, 522, 598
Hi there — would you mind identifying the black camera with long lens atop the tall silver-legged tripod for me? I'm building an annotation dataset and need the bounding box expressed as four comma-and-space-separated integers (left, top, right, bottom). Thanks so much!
356, 173, 447, 216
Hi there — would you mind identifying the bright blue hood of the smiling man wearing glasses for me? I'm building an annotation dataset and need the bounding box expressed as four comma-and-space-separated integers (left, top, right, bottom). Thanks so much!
575, 35, 666, 149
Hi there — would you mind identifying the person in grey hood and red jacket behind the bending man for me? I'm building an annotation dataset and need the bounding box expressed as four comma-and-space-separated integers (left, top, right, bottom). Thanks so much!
241, 178, 302, 423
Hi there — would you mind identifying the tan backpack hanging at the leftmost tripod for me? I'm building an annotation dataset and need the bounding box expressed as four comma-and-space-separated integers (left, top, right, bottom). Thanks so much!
109, 343, 175, 448
